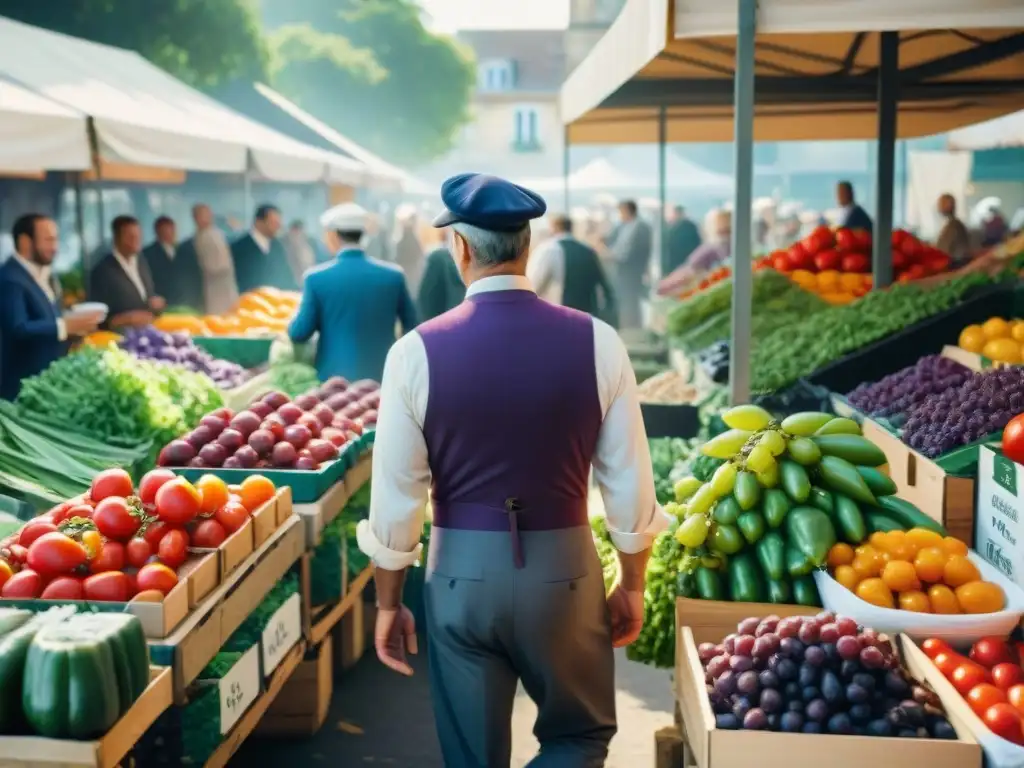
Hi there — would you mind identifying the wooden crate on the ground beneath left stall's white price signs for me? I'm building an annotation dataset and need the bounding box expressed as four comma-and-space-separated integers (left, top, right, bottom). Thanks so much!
256, 635, 334, 736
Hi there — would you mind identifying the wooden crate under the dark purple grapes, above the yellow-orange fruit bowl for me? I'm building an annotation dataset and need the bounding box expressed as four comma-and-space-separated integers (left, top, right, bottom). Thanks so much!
861, 419, 975, 546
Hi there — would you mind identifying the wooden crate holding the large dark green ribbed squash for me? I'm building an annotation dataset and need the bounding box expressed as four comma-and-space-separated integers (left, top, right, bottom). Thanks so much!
0, 667, 172, 768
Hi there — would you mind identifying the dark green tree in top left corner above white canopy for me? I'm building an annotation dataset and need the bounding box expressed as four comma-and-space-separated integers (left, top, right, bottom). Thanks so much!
0, 0, 267, 89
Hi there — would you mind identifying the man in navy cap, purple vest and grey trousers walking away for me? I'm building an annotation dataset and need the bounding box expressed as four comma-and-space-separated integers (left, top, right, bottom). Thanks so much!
357, 174, 667, 768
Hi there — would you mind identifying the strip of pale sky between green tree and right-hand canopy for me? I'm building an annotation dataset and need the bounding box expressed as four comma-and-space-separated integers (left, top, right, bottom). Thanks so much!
420, 0, 569, 31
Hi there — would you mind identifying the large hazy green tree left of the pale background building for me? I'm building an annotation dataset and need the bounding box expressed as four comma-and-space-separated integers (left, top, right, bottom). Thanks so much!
261, 0, 475, 164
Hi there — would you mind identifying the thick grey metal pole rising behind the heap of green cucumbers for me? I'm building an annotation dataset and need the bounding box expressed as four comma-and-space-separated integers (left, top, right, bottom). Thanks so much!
729, 0, 758, 403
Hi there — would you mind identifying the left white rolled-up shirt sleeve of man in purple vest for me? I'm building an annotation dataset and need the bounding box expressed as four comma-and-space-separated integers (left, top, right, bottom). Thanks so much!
356, 332, 430, 570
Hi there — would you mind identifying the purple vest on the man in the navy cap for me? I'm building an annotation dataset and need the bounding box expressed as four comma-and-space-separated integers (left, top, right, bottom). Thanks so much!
417, 290, 601, 530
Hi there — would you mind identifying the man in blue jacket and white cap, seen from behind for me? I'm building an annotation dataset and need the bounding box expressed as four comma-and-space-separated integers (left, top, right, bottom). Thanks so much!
288, 203, 416, 381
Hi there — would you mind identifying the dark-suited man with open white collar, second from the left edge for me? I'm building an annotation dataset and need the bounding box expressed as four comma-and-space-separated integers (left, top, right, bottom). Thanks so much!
89, 216, 167, 328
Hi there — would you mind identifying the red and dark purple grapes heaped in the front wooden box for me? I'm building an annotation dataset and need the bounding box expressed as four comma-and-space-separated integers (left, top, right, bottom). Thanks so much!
697, 611, 956, 738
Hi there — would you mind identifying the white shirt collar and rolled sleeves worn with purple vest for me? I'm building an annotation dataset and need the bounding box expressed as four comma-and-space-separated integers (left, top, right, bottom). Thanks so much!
356, 275, 669, 570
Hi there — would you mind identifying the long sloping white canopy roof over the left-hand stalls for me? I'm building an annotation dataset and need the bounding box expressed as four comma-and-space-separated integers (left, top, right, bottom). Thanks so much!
0, 17, 365, 183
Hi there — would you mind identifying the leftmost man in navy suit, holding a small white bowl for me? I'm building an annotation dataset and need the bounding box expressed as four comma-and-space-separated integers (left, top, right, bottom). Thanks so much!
0, 213, 99, 400
